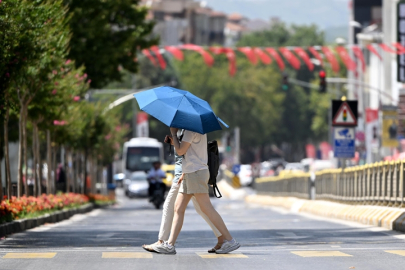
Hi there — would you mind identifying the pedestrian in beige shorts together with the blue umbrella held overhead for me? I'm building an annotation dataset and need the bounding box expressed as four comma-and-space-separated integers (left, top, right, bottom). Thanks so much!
135, 86, 240, 254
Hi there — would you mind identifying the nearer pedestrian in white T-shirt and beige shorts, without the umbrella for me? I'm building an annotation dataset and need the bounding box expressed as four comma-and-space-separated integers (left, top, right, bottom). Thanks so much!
153, 128, 240, 254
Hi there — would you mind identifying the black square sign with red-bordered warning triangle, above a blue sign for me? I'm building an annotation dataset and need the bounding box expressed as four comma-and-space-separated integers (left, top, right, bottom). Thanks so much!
332, 100, 357, 127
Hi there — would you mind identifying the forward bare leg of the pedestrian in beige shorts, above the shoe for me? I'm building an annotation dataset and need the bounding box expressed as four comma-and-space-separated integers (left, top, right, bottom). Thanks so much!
168, 193, 193, 245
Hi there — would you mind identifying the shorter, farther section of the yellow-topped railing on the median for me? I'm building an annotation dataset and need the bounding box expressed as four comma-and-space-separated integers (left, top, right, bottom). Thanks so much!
255, 173, 311, 199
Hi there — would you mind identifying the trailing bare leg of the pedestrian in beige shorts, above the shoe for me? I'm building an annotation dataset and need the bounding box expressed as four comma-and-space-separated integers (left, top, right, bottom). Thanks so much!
194, 193, 232, 241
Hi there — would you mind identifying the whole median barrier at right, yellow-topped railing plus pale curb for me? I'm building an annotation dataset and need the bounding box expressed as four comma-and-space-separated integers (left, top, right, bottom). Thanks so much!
245, 161, 405, 232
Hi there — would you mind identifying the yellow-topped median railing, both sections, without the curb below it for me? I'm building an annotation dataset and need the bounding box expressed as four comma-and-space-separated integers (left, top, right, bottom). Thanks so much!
256, 160, 405, 207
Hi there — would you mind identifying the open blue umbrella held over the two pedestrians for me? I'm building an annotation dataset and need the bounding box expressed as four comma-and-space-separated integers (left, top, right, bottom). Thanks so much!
134, 86, 229, 134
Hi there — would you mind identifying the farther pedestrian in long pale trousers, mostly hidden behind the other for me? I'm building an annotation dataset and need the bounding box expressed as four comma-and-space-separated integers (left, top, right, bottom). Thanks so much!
142, 131, 224, 253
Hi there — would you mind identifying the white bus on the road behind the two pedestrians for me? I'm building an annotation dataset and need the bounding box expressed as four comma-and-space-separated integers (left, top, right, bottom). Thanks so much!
122, 138, 163, 179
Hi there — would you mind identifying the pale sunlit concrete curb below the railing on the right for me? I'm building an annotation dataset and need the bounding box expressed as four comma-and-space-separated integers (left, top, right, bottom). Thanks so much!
245, 195, 405, 232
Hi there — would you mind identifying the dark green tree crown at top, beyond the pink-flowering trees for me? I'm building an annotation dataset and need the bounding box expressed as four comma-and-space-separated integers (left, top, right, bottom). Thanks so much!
64, 0, 158, 88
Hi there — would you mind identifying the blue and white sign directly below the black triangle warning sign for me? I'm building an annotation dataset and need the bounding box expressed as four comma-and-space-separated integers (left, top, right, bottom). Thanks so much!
333, 127, 356, 158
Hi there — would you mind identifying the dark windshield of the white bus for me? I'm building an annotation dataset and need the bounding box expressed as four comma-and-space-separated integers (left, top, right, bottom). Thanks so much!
126, 147, 160, 171
